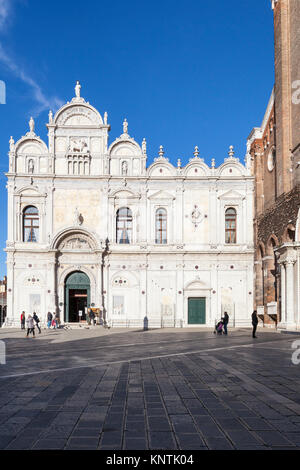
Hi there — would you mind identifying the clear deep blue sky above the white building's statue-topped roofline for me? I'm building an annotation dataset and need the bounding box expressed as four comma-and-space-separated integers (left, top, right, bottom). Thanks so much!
0, 0, 274, 277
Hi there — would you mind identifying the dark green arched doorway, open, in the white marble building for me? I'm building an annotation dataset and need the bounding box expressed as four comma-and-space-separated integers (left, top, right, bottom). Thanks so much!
65, 271, 91, 323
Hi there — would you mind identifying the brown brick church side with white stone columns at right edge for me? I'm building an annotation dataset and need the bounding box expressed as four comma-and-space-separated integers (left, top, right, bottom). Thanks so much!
248, 0, 300, 328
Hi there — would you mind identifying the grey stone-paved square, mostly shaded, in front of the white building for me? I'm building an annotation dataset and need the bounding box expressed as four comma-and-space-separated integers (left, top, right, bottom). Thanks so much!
0, 328, 300, 450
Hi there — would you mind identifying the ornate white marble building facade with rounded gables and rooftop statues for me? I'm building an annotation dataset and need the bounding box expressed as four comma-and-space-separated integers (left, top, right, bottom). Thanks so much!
6, 83, 254, 327
